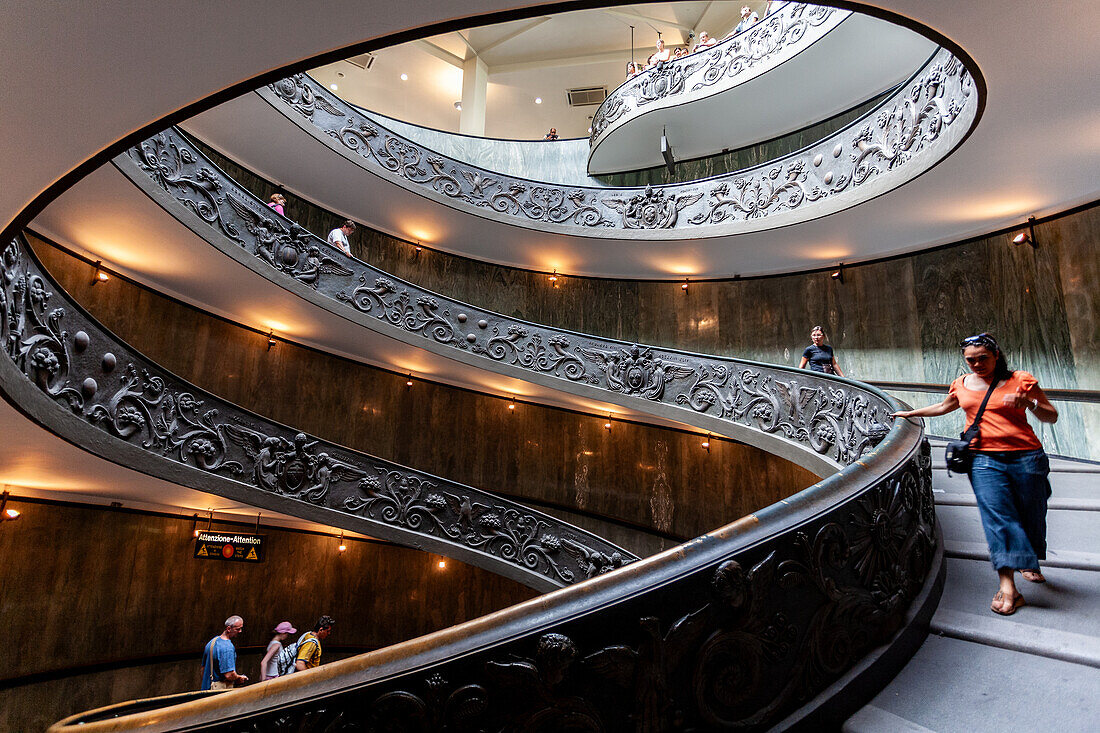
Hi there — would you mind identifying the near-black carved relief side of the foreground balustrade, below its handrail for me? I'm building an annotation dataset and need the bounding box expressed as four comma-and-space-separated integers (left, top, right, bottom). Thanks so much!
221, 442, 936, 732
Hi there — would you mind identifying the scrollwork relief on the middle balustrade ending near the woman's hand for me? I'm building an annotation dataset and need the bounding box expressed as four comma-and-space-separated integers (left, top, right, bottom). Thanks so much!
116, 130, 902, 464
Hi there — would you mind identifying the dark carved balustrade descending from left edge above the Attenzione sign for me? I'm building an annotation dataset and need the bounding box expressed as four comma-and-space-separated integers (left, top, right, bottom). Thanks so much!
0, 234, 637, 590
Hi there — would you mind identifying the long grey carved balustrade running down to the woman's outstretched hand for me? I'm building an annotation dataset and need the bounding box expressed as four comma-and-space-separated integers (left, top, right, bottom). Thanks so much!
114, 130, 890, 475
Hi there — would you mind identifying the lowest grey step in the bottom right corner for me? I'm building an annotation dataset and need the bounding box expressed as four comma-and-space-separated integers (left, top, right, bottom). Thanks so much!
858, 633, 1100, 733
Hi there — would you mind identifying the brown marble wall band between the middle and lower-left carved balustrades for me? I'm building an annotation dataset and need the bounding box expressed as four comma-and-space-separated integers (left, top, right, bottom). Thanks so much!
27, 235, 816, 546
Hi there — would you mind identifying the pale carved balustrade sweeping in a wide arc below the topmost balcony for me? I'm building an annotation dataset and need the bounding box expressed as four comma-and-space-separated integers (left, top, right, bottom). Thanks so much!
256, 44, 980, 240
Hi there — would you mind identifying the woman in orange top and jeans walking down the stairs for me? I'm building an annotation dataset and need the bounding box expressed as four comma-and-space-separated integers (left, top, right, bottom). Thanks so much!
893, 333, 1058, 616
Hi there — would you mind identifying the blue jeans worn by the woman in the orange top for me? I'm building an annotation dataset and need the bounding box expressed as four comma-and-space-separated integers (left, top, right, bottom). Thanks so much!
970, 448, 1051, 570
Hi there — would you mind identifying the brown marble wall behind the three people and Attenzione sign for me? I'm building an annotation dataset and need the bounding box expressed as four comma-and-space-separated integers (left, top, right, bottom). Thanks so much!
0, 500, 536, 731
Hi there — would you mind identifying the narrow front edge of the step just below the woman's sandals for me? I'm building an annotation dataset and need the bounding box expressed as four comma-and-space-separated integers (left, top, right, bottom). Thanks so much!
931, 607, 1100, 668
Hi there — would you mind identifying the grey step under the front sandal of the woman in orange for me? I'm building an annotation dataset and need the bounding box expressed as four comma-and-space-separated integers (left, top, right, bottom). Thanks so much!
937, 558, 1100, 637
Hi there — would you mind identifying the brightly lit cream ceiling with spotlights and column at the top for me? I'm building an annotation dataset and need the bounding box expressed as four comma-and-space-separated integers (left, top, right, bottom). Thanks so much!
310, 0, 768, 140
